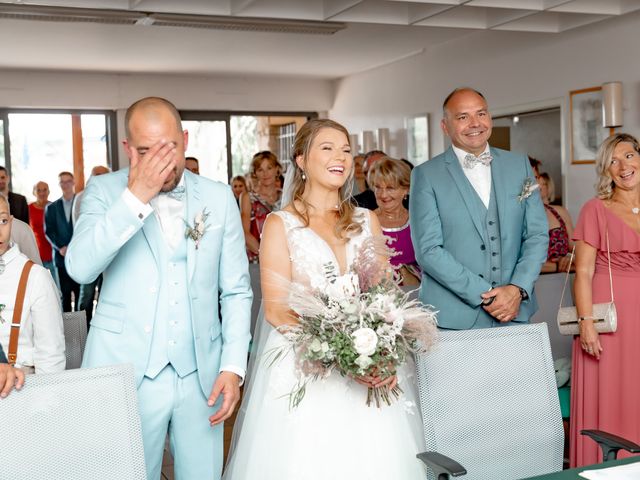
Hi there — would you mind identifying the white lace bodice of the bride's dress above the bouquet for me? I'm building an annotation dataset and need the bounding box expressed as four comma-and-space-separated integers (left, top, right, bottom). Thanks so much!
272, 208, 372, 288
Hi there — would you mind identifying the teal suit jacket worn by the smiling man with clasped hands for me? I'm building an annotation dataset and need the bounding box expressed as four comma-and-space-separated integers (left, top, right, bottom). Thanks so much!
409, 148, 549, 329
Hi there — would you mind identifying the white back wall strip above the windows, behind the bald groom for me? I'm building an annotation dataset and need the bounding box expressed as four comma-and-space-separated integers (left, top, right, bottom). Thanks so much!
0, 70, 334, 166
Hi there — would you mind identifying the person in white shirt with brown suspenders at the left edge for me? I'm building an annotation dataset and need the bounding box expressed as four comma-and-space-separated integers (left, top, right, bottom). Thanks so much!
0, 196, 66, 373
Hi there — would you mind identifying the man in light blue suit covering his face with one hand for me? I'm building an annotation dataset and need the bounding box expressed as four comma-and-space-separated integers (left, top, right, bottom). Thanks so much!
66, 97, 252, 480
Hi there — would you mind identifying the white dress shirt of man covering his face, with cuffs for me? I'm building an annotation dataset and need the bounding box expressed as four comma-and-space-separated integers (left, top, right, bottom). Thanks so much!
122, 180, 246, 379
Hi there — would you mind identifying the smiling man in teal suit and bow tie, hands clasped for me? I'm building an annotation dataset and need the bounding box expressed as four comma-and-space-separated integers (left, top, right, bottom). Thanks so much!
409, 88, 549, 330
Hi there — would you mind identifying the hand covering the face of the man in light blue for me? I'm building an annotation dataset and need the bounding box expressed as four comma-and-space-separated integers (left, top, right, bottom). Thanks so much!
127, 140, 177, 203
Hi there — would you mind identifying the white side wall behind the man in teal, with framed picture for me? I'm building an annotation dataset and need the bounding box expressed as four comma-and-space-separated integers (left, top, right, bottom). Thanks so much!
329, 12, 640, 217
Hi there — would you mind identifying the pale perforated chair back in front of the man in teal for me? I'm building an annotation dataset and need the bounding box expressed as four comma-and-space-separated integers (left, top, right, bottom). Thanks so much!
417, 324, 564, 480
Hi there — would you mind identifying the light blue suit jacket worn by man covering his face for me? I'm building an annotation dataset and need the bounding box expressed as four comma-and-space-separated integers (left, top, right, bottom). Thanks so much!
65, 169, 253, 397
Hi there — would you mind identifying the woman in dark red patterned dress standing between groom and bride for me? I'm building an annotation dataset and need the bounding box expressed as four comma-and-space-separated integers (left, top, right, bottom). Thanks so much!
240, 150, 282, 263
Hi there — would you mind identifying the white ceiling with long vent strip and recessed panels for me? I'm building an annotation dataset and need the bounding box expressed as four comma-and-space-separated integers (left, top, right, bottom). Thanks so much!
0, 0, 640, 78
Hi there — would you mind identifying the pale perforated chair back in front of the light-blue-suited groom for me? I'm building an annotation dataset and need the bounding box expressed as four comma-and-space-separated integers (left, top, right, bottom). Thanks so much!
0, 365, 146, 480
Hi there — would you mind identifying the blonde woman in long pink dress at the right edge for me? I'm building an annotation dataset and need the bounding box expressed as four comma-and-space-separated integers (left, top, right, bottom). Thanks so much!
570, 133, 640, 467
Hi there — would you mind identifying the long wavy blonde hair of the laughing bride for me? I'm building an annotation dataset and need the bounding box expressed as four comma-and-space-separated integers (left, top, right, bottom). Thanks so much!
289, 119, 362, 239
